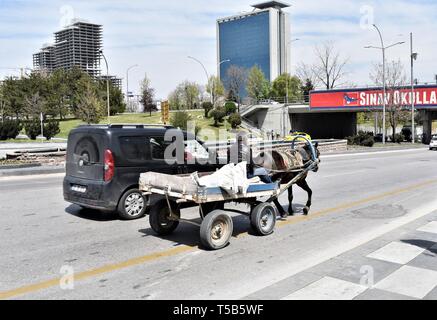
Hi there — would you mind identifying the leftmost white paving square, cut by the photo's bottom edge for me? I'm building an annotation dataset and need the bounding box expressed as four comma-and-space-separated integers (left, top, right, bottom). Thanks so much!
281, 277, 368, 300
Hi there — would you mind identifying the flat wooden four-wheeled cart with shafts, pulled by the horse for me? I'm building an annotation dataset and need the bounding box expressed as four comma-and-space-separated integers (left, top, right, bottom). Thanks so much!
140, 137, 319, 250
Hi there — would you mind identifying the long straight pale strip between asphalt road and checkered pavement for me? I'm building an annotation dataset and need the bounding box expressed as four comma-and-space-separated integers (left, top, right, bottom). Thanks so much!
214, 200, 437, 300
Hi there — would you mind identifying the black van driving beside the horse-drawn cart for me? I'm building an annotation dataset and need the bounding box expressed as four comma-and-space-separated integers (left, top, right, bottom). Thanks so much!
63, 125, 218, 220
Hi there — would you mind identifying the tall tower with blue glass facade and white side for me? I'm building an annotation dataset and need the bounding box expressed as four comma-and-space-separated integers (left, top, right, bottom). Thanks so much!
217, 1, 291, 96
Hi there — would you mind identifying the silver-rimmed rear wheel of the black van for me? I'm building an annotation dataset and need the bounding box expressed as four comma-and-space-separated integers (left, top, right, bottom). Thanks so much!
118, 189, 147, 220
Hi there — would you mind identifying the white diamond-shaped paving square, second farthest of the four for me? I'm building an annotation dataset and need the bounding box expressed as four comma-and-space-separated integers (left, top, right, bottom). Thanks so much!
367, 242, 425, 264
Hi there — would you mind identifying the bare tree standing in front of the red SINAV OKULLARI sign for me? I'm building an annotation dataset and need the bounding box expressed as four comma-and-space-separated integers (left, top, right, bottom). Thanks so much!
370, 60, 411, 140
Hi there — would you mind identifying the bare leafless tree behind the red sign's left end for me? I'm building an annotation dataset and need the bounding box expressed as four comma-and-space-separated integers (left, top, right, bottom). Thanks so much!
309, 42, 348, 90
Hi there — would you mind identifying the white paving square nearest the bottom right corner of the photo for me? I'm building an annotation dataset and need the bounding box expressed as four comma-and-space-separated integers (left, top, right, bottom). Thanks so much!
374, 266, 437, 299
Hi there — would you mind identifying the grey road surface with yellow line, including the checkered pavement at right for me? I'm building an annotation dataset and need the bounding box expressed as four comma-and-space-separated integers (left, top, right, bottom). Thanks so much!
0, 149, 437, 299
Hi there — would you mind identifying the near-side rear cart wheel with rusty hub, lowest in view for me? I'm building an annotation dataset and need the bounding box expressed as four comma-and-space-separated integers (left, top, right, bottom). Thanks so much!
200, 210, 234, 250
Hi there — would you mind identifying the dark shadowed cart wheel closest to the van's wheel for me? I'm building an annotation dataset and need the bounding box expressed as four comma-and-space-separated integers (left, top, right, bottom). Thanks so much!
149, 201, 181, 236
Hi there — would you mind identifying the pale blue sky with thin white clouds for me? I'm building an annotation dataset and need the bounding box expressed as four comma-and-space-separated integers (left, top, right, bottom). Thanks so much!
0, 0, 437, 99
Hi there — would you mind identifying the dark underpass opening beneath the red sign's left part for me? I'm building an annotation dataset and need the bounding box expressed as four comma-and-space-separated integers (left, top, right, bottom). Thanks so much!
291, 112, 357, 139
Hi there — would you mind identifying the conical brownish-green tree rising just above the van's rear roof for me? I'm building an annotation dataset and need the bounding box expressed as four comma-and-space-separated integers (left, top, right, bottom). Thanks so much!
75, 80, 105, 124
